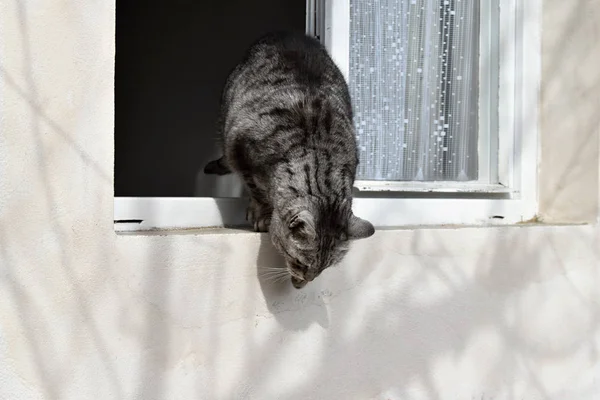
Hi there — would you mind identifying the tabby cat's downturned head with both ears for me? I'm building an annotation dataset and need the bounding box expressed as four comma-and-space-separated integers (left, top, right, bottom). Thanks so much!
269, 199, 375, 289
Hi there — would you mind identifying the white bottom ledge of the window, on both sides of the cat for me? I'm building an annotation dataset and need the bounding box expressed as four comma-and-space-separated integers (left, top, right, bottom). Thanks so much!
114, 197, 535, 231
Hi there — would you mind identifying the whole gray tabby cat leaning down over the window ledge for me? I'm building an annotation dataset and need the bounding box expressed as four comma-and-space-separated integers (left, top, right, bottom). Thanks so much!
204, 33, 375, 288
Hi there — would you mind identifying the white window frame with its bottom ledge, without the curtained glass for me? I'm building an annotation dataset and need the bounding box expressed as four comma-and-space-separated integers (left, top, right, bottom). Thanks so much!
115, 0, 542, 231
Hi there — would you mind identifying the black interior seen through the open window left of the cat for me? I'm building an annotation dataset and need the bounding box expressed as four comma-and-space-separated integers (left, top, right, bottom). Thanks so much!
115, 0, 306, 197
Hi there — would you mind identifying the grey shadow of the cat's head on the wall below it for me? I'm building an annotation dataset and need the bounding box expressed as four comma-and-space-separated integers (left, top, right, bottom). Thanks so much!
256, 233, 329, 331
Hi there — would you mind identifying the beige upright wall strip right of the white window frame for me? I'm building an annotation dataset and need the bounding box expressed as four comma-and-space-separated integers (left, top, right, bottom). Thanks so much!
540, 0, 600, 222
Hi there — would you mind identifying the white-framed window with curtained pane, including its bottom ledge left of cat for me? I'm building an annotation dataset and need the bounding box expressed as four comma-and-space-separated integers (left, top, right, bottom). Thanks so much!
115, 0, 541, 229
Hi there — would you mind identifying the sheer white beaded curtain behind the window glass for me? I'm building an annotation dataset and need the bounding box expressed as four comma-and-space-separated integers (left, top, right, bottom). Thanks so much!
350, 0, 479, 181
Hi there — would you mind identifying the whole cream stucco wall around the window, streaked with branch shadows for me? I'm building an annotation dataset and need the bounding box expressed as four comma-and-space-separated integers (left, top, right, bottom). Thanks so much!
0, 0, 600, 400
